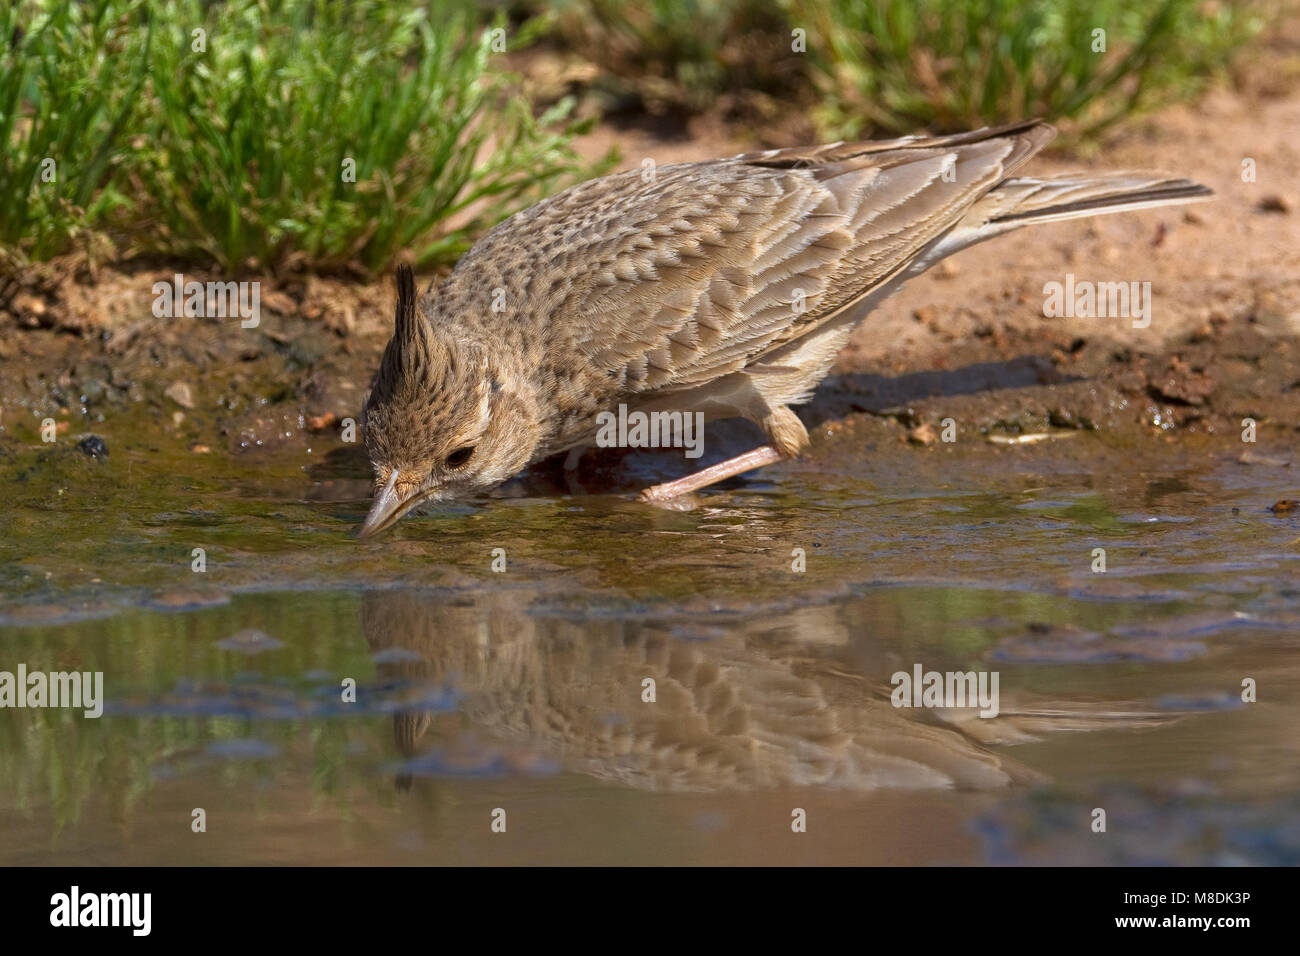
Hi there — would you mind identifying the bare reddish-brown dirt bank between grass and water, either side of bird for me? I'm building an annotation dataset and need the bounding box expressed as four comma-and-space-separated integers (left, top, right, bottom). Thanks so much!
0, 30, 1300, 463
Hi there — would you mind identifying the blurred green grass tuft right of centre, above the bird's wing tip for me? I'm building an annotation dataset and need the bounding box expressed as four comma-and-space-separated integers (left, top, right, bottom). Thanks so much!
787, 0, 1262, 138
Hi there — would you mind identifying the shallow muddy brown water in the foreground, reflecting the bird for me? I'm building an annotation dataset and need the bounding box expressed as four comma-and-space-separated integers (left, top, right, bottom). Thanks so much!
0, 418, 1300, 865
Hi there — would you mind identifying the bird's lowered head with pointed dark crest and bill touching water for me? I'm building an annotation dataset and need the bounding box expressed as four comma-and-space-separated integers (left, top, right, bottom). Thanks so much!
360, 267, 540, 537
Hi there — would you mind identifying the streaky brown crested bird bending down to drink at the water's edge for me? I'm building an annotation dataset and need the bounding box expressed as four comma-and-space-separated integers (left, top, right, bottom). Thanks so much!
359, 120, 1213, 537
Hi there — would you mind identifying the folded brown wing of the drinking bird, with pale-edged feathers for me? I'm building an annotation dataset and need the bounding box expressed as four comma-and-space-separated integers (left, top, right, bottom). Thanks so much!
553, 122, 1054, 393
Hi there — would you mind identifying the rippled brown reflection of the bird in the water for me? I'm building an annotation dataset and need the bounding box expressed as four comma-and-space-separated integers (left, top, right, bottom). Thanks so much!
361, 591, 1174, 791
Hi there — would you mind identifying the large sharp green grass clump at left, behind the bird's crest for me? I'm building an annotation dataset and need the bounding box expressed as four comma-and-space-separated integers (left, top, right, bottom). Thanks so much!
0, 0, 600, 273
